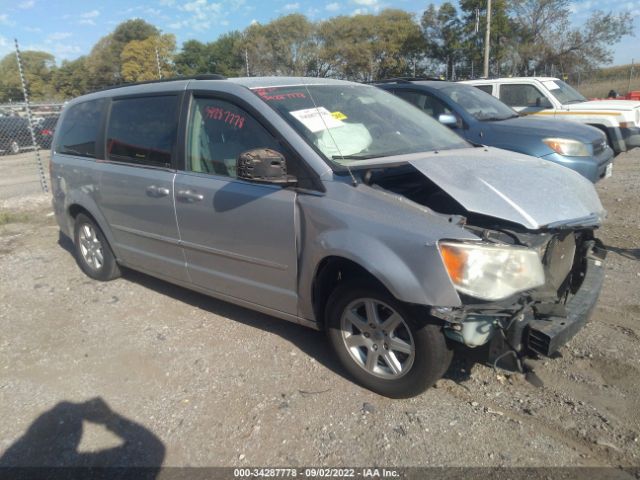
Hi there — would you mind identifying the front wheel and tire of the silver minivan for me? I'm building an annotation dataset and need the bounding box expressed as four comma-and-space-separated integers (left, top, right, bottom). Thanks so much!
325, 281, 453, 398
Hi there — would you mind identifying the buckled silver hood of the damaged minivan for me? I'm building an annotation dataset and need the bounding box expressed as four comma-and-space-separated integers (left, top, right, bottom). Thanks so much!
405, 148, 605, 230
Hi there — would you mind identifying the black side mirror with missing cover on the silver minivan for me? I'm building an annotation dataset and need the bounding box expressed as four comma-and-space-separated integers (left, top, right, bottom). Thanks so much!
236, 148, 298, 187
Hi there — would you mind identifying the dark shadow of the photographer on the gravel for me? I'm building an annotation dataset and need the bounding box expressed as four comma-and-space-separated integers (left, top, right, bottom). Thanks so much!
0, 398, 165, 479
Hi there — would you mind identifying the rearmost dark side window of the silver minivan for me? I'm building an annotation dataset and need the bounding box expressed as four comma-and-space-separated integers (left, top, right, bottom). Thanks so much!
55, 100, 104, 158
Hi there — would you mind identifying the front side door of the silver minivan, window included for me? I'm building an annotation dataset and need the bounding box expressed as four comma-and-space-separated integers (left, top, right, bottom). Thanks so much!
175, 96, 297, 314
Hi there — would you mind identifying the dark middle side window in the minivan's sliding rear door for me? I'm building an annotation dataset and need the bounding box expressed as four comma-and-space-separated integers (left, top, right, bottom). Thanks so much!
107, 95, 178, 167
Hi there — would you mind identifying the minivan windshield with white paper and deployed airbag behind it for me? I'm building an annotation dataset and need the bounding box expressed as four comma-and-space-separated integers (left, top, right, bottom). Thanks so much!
254, 84, 469, 165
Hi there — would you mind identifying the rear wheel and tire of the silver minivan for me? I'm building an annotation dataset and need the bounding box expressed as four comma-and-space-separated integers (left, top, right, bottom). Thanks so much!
73, 213, 120, 282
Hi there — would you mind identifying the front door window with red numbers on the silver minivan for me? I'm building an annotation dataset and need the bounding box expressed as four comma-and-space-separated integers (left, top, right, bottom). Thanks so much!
187, 98, 284, 177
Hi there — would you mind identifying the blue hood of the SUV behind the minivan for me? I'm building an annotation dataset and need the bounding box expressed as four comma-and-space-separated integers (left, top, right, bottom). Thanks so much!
482, 116, 604, 144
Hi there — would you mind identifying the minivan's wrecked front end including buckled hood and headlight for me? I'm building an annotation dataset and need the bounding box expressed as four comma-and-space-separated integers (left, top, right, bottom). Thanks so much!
371, 149, 606, 371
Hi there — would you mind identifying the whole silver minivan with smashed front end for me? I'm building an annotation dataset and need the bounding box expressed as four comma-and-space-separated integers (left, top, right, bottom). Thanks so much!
51, 76, 604, 397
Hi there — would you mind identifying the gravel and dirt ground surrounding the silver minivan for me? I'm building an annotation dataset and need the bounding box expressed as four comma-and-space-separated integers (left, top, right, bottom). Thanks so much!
0, 152, 640, 466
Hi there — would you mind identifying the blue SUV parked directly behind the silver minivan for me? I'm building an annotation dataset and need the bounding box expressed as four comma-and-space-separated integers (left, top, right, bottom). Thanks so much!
378, 80, 614, 183
